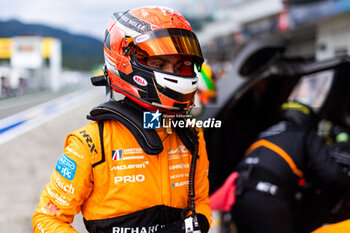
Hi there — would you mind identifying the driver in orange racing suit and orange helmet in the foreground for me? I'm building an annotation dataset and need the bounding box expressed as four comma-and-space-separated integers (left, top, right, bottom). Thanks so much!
33, 7, 211, 233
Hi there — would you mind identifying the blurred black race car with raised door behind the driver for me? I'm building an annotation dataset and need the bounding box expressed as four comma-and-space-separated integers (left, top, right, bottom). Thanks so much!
205, 41, 350, 232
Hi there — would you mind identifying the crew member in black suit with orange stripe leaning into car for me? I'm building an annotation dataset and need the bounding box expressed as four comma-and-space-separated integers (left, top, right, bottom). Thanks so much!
233, 101, 350, 233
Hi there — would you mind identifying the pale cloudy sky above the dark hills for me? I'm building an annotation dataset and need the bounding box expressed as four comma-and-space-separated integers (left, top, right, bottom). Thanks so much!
0, 0, 183, 40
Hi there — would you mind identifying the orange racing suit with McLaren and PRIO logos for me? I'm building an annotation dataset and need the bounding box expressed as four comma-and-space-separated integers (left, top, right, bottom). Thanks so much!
33, 120, 211, 233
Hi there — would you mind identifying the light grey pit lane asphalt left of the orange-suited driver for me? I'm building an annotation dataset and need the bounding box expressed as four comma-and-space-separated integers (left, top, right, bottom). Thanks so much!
0, 86, 104, 233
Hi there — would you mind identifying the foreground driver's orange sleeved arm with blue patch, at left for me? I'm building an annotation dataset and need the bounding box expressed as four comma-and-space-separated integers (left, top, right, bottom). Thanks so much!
33, 134, 92, 233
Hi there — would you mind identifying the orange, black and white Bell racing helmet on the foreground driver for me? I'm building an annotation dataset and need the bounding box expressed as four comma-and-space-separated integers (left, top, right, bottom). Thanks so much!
104, 6, 204, 113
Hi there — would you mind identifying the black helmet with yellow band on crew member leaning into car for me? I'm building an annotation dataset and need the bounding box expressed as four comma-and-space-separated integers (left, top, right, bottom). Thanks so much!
281, 101, 317, 125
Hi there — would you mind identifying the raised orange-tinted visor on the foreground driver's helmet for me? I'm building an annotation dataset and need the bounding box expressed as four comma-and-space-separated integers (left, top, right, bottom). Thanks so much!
133, 28, 204, 66
